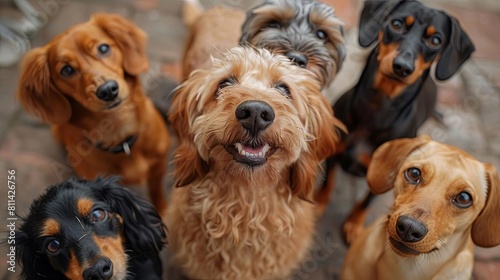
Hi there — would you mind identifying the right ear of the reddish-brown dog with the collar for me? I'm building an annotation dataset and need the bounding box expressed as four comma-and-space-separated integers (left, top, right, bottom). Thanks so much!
92, 14, 149, 76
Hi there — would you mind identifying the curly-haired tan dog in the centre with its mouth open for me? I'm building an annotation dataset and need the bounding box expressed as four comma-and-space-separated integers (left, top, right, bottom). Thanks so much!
167, 47, 341, 279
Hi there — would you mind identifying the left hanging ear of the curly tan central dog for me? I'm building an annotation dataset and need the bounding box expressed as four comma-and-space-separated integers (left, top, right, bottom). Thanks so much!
168, 70, 207, 187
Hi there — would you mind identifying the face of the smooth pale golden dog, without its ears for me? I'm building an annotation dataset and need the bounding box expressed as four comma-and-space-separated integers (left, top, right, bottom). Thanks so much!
387, 142, 488, 256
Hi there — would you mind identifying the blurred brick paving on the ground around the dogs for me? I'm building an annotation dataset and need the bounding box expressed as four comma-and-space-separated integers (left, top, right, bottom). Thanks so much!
0, 0, 500, 280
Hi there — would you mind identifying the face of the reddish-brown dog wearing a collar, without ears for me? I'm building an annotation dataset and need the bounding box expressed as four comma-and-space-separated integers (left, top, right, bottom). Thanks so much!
48, 23, 130, 112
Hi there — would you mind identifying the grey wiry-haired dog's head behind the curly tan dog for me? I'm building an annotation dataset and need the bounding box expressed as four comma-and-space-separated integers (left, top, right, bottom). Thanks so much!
240, 0, 345, 87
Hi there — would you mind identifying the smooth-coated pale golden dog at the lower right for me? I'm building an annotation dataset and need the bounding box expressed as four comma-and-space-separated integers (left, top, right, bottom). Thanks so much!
342, 136, 500, 279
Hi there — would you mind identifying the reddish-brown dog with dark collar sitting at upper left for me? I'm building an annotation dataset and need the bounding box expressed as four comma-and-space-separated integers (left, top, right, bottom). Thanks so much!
17, 14, 169, 213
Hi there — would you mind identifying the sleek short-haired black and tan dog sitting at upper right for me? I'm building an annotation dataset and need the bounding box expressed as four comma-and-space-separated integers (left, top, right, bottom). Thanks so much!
316, 1, 475, 243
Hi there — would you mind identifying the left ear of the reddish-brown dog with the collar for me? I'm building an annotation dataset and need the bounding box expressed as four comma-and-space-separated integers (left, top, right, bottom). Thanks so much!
17, 48, 71, 124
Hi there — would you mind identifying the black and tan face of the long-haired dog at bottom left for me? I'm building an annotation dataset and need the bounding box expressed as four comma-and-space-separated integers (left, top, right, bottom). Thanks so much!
33, 196, 127, 280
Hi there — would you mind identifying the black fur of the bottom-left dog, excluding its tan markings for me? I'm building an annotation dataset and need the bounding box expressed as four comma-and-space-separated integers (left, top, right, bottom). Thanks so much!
16, 178, 166, 280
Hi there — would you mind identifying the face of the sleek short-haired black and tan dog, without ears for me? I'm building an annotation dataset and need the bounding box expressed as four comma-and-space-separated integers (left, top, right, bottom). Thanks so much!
377, 2, 451, 97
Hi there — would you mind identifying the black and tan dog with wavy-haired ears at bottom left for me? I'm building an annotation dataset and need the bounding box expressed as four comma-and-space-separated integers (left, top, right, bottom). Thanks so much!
16, 178, 166, 280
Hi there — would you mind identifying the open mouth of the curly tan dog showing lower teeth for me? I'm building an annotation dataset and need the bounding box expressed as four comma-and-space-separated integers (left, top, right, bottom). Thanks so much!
224, 143, 277, 166
